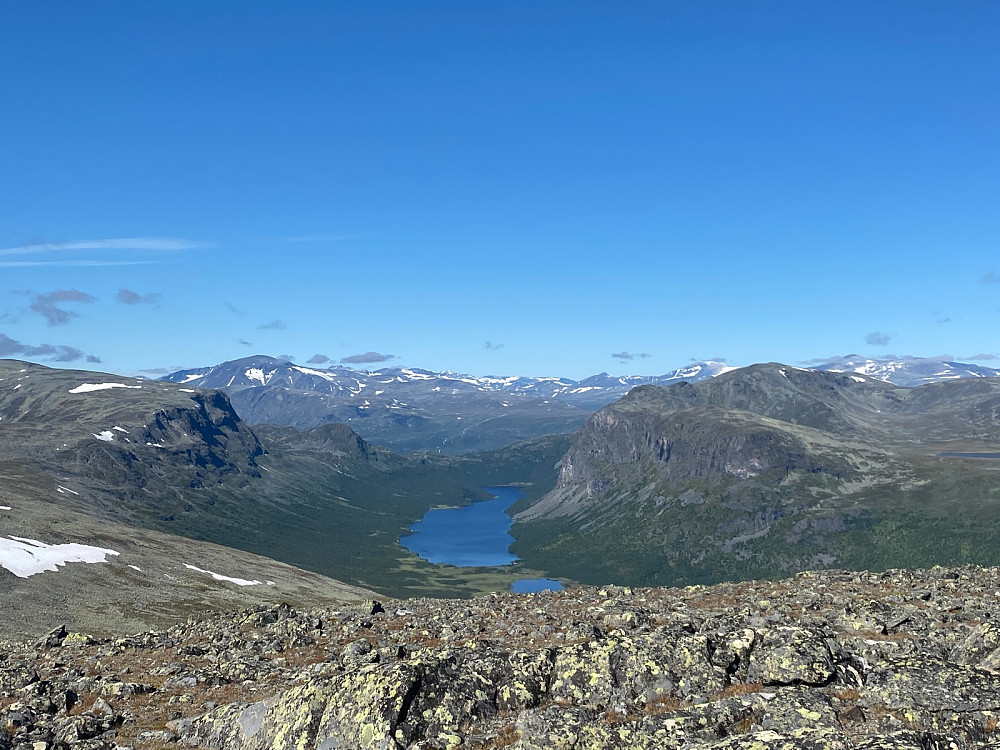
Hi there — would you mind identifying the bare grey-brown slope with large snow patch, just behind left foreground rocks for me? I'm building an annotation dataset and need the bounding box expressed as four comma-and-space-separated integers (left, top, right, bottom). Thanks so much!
0, 464, 372, 640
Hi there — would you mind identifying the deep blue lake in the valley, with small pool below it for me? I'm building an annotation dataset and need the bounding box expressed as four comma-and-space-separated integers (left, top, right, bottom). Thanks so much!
399, 487, 562, 592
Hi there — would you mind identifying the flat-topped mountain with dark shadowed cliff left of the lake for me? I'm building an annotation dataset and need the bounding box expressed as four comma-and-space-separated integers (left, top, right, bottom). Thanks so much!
0, 361, 265, 525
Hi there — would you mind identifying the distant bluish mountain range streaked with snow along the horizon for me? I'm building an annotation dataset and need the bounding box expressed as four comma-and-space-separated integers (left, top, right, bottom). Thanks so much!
163, 355, 1000, 454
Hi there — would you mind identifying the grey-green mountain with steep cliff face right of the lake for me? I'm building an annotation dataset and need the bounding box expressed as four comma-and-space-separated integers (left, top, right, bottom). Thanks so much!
513, 365, 1000, 584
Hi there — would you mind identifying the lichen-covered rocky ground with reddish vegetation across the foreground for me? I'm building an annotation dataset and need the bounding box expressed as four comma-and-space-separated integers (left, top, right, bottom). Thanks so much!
0, 568, 1000, 750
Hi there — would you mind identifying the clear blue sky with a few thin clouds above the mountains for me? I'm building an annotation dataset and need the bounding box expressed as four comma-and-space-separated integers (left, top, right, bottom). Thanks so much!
0, 0, 1000, 377
